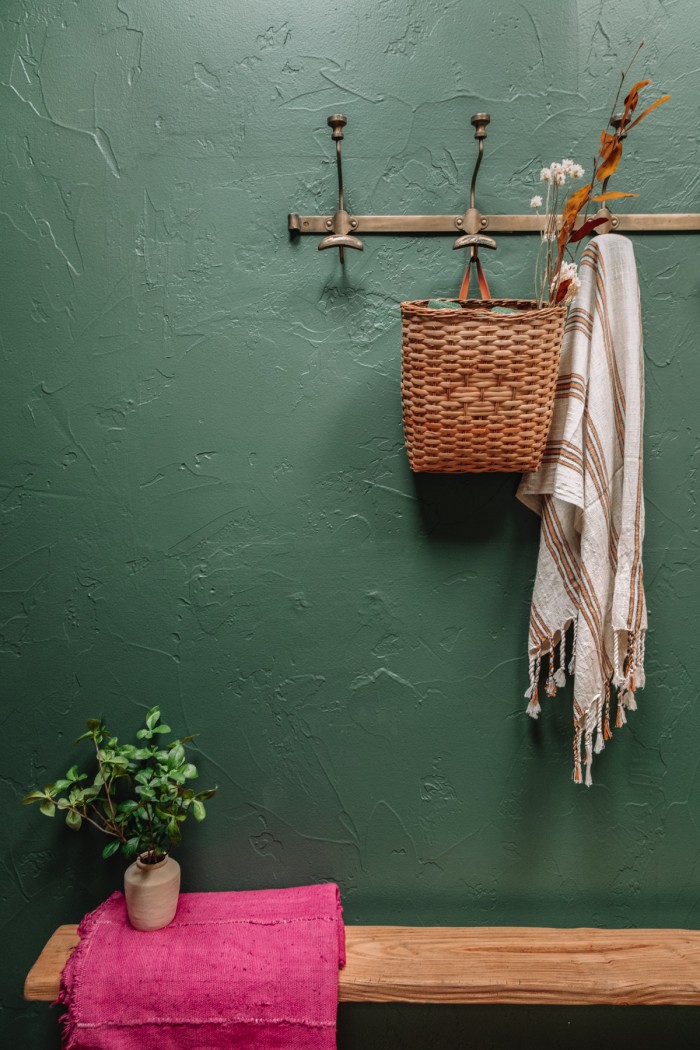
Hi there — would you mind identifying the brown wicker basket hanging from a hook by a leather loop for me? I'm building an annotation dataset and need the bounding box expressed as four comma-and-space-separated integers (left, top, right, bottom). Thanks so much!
401, 299, 567, 474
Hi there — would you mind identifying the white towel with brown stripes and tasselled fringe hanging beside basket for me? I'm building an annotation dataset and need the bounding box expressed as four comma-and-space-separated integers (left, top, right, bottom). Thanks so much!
517, 234, 646, 784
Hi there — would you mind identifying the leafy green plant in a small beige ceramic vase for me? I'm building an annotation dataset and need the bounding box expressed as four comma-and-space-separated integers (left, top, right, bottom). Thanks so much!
22, 707, 216, 930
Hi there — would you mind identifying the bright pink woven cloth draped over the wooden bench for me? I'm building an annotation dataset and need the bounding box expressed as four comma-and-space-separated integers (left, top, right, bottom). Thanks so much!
60, 883, 345, 1050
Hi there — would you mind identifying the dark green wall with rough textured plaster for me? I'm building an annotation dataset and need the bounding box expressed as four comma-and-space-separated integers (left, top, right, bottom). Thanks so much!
0, 0, 700, 1050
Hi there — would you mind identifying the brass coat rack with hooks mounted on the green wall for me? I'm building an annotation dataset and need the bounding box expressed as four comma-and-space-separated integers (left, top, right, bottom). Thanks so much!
288, 113, 700, 263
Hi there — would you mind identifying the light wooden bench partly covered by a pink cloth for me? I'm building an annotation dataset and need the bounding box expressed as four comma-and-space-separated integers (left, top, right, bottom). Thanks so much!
24, 926, 700, 1006
